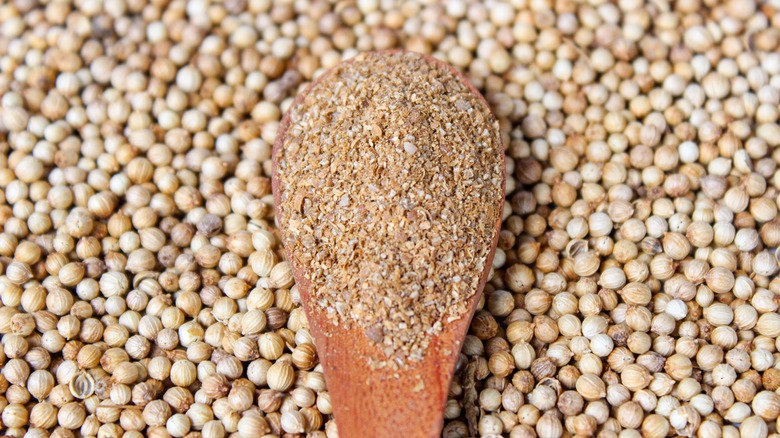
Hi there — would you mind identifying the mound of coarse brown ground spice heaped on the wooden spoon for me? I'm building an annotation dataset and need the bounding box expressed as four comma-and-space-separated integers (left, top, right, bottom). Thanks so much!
275, 52, 503, 364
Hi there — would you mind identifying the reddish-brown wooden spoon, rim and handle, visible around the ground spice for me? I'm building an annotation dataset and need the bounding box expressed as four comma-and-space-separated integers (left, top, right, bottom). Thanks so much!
273, 51, 506, 438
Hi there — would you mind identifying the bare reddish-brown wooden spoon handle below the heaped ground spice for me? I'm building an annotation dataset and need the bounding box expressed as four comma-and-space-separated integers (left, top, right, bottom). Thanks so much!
312, 308, 466, 438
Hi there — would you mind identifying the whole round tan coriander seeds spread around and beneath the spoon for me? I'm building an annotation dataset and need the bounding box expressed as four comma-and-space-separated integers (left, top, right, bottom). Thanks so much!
0, 0, 780, 438
